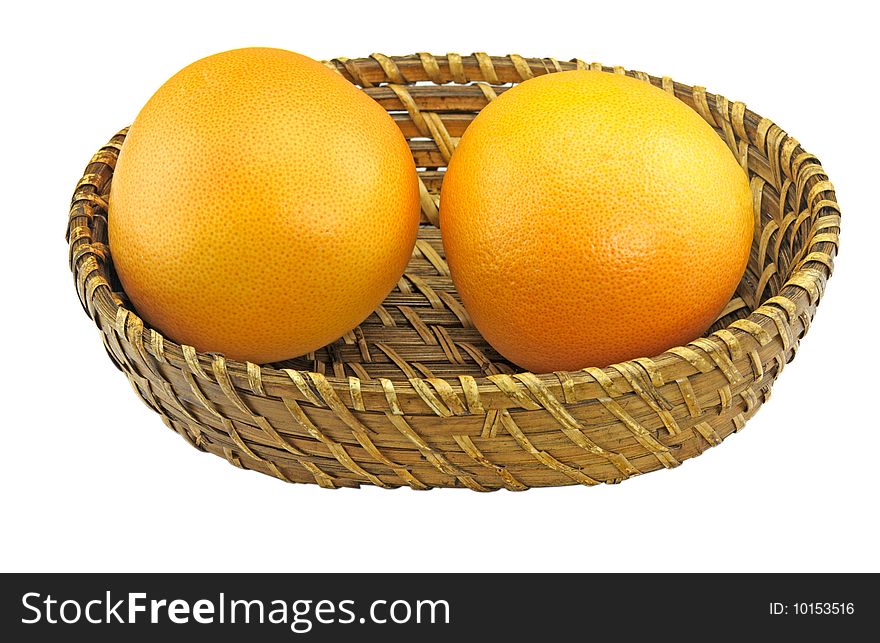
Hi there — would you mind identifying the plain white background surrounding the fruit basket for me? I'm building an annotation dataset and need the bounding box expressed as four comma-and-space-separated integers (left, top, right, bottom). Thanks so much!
0, 0, 880, 572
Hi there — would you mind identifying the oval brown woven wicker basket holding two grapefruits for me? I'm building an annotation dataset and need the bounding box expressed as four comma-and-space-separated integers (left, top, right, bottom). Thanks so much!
67, 53, 840, 491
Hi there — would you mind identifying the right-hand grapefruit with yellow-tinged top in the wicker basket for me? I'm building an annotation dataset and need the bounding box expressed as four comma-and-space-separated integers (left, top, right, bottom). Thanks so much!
440, 70, 754, 372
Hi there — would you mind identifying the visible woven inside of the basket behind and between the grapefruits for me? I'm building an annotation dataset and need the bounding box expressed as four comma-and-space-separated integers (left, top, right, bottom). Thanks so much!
98, 57, 808, 380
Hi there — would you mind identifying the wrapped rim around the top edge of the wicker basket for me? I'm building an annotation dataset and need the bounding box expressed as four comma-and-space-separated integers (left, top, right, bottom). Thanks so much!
66, 53, 840, 415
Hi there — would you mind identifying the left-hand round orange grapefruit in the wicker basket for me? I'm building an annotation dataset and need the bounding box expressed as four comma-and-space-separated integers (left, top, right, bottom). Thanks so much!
108, 48, 419, 362
